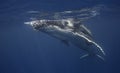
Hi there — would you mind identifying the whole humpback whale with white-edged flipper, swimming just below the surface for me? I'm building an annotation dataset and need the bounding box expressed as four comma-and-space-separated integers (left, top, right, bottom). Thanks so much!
25, 19, 105, 60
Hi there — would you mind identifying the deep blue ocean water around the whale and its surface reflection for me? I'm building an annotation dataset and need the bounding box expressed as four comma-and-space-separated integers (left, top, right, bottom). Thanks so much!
0, 0, 120, 73
